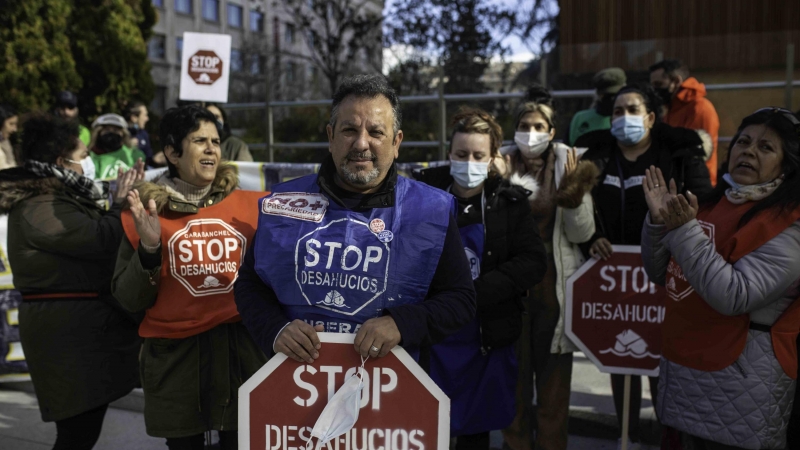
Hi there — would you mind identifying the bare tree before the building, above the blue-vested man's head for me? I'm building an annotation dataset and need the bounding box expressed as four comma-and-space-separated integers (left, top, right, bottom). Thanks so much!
278, 0, 383, 93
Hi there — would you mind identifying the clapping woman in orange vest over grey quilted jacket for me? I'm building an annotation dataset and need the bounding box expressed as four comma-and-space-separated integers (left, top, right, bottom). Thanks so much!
642, 108, 800, 449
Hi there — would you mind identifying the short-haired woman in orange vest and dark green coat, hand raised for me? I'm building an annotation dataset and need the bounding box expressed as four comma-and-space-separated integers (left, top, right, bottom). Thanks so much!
112, 106, 266, 450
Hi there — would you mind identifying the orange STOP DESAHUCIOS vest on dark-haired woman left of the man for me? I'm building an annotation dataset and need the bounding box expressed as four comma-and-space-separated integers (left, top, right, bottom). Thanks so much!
122, 190, 267, 339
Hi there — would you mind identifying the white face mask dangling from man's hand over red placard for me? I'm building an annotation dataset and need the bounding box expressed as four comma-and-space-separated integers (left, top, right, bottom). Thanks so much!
306, 358, 369, 450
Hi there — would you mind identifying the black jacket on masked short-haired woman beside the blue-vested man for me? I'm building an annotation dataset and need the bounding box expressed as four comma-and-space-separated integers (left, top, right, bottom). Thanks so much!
415, 166, 547, 347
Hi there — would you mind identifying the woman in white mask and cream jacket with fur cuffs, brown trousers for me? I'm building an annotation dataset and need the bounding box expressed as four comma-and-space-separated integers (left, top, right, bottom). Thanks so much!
501, 86, 597, 450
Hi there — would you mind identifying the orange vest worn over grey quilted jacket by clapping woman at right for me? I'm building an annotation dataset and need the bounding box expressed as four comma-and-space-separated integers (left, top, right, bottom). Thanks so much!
661, 197, 800, 379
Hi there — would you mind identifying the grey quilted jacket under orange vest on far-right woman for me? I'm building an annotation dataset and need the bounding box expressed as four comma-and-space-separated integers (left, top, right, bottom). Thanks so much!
642, 216, 800, 449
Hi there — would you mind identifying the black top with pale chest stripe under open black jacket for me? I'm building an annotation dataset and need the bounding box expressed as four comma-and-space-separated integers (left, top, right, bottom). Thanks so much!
597, 143, 659, 245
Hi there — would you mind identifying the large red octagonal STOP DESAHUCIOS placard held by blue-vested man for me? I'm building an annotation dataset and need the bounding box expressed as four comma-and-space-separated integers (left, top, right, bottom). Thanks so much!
239, 333, 450, 450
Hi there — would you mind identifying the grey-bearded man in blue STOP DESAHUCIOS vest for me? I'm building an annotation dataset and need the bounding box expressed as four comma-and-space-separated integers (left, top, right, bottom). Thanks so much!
235, 75, 476, 366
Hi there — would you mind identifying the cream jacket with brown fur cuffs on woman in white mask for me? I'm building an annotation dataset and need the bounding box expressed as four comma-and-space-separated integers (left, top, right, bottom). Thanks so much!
504, 143, 600, 354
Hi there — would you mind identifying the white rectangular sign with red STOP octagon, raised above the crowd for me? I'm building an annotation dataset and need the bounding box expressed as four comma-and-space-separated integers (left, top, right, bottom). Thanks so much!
178, 33, 231, 103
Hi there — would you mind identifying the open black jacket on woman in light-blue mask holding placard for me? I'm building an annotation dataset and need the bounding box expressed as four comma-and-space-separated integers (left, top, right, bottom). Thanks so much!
575, 122, 712, 248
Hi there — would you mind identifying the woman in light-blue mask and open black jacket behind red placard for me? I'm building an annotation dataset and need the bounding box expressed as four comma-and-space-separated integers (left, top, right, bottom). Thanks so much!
576, 84, 711, 450
